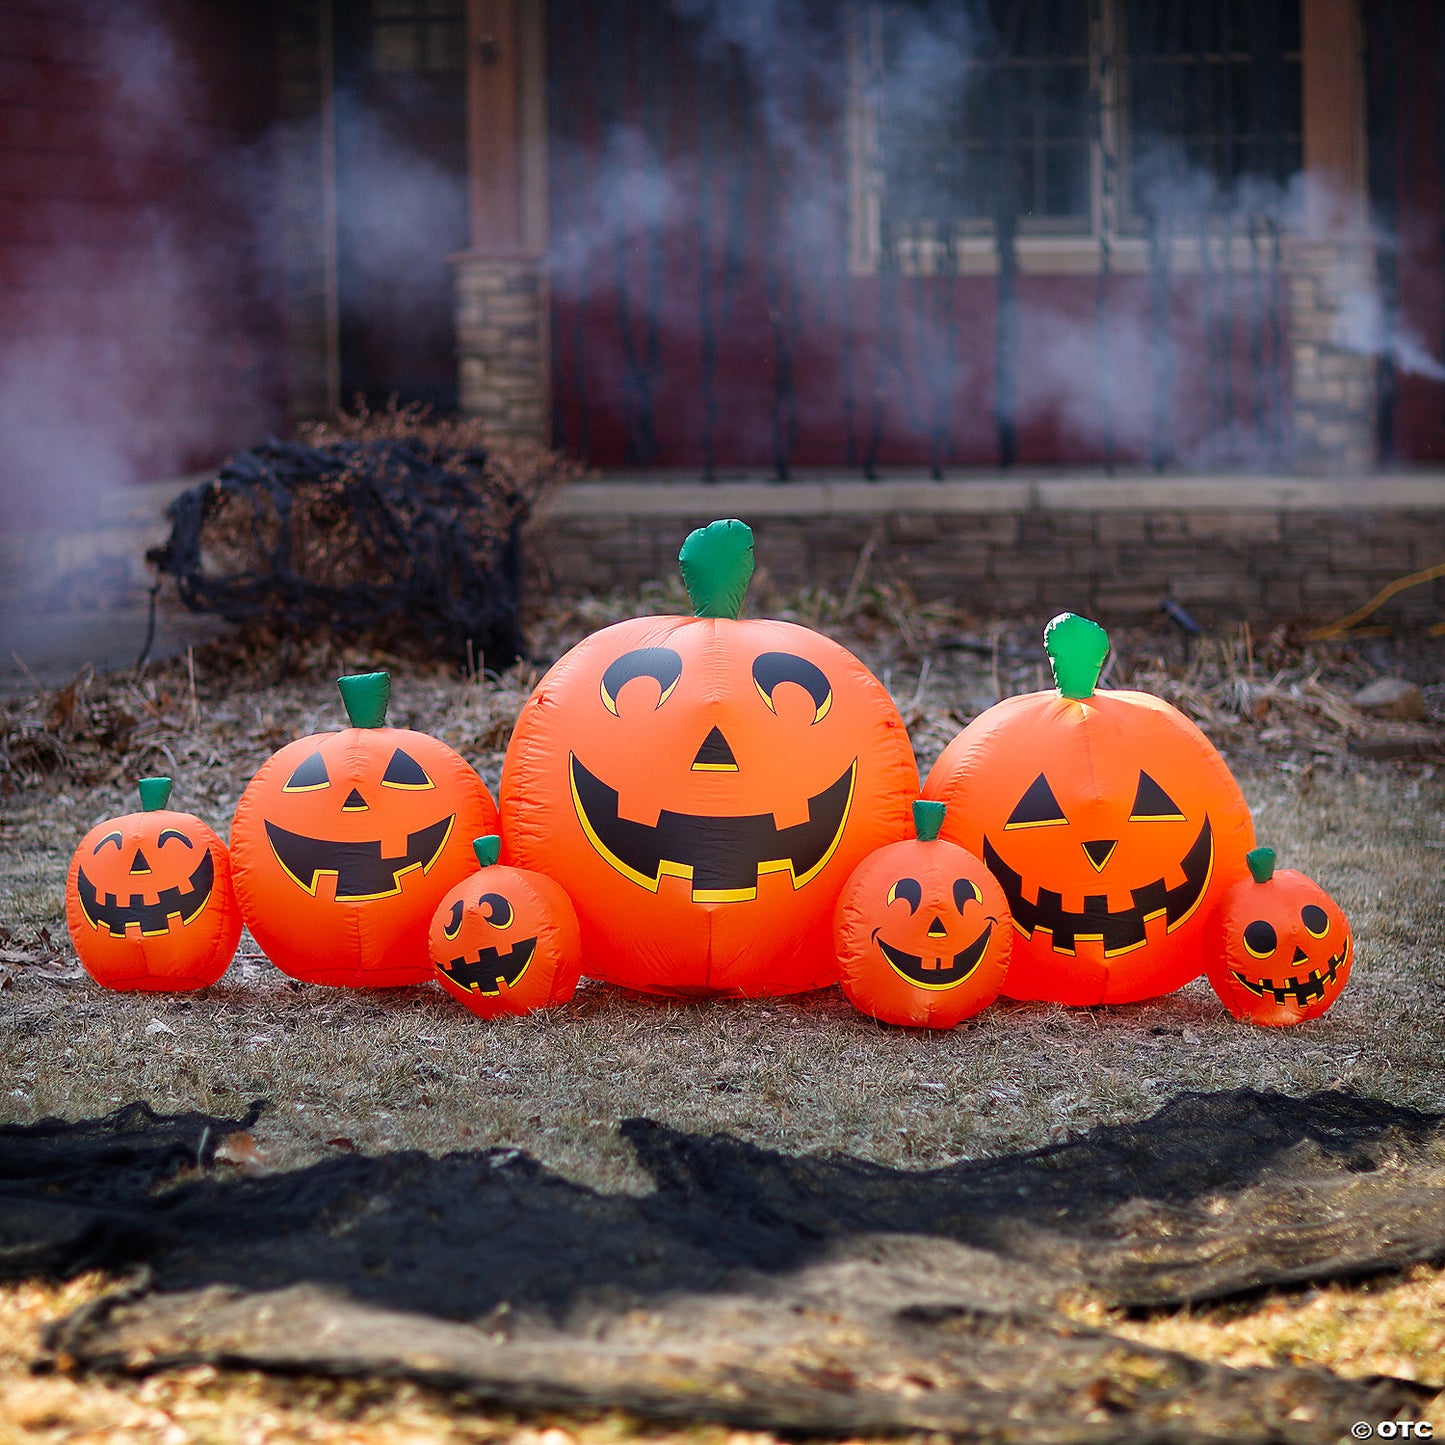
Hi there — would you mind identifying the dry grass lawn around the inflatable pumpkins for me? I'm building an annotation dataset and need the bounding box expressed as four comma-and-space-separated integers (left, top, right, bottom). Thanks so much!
0, 588, 1445, 1445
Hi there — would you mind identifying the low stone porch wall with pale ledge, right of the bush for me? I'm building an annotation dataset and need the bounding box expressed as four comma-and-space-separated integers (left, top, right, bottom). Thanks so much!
529, 477, 1445, 624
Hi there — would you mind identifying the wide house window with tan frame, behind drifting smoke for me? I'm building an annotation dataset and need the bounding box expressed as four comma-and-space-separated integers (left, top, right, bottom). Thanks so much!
851, 0, 1302, 272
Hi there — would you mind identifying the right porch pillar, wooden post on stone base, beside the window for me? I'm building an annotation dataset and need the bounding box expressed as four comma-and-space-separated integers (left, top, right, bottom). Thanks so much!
1283, 0, 1380, 473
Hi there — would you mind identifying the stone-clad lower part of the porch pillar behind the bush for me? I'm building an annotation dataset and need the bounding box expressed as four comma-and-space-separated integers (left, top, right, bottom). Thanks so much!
452, 251, 552, 442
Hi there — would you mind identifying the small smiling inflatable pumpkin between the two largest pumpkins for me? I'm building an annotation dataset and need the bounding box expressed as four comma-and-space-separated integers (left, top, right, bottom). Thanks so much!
834, 802, 1013, 1029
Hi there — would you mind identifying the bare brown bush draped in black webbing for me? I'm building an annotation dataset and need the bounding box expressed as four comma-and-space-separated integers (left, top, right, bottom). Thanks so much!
150, 395, 575, 660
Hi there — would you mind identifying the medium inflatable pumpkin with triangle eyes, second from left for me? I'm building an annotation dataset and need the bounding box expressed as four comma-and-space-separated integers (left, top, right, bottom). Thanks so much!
231, 672, 497, 988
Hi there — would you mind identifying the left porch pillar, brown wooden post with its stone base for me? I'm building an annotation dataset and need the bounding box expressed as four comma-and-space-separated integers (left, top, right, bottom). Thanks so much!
452, 0, 552, 442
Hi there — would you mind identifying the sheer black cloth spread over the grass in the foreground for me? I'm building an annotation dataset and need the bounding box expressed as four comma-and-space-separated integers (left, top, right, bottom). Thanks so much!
0, 1090, 1445, 1442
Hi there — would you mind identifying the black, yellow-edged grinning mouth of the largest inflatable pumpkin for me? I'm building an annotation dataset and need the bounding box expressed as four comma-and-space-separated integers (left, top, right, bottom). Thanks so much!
572, 756, 858, 903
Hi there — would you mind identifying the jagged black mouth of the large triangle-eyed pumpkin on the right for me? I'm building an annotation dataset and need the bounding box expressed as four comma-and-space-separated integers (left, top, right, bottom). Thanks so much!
984, 818, 1214, 958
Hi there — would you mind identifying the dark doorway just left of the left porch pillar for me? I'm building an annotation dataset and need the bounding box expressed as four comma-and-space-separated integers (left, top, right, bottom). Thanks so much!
335, 0, 467, 410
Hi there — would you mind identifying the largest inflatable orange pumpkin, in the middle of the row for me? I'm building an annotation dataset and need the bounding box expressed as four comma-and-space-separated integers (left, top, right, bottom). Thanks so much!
501, 522, 918, 994
